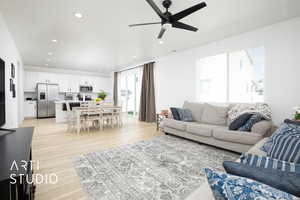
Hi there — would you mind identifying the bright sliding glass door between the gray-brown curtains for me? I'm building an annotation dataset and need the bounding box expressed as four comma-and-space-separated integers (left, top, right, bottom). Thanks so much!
119, 68, 142, 116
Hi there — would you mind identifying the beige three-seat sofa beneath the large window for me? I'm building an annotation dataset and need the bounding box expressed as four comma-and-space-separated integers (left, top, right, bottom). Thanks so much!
162, 102, 272, 153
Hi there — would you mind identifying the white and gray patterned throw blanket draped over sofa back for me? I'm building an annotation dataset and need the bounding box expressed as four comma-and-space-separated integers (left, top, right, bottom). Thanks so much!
228, 103, 272, 123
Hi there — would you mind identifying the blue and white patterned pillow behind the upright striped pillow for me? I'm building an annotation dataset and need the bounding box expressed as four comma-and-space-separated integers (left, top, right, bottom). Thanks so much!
260, 123, 300, 152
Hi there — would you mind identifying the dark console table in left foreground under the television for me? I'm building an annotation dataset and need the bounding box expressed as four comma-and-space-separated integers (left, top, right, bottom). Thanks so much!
0, 128, 35, 200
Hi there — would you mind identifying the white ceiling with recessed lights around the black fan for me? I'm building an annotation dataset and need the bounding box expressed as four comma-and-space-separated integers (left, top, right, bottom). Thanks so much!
0, 0, 300, 73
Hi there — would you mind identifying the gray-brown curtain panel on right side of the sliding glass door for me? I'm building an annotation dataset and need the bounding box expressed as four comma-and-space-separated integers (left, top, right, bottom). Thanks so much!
139, 62, 156, 122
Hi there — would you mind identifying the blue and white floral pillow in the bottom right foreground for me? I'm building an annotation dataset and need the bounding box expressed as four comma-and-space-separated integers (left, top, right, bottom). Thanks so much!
205, 168, 299, 200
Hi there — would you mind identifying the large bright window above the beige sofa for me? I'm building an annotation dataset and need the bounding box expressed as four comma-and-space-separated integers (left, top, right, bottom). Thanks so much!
197, 47, 265, 103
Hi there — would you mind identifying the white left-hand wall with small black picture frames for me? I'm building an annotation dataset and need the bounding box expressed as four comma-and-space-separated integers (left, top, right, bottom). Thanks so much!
0, 13, 23, 128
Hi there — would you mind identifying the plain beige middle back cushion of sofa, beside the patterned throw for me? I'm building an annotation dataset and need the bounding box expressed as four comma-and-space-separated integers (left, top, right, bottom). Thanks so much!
201, 103, 228, 126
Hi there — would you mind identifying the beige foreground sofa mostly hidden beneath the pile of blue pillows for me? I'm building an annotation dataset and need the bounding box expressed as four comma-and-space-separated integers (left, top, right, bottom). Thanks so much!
186, 138, 267, 200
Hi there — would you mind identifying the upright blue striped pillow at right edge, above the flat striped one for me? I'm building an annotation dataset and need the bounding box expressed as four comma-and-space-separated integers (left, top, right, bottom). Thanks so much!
267, 135, 300, 164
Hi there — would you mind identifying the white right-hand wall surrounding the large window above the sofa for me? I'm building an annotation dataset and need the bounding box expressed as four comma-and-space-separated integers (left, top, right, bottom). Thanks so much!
155, 17, 300, 124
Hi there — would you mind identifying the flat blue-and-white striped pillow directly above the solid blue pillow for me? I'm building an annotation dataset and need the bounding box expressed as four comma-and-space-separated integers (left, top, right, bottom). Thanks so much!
240, 153, 300, 174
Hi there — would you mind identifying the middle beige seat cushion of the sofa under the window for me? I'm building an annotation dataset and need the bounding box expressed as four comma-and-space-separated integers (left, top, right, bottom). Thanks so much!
186, 123, 218, 137
